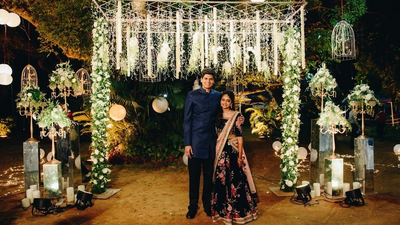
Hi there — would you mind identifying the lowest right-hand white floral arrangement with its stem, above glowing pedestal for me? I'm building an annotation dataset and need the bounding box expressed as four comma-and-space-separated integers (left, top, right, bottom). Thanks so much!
317, 101, 351, 158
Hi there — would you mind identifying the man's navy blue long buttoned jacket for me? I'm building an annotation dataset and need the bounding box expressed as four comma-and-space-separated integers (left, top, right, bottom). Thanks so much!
183, 88, 221, 159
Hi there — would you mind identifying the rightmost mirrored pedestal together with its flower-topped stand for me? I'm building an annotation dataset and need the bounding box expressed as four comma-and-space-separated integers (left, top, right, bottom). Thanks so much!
347, 84, 379, 193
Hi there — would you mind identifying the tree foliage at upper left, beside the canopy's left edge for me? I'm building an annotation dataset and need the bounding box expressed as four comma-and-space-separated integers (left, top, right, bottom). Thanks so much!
29, 0, 93, 59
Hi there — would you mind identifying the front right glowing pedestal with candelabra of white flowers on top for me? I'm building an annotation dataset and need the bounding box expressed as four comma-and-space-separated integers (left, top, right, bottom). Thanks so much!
317, 101, 350, 198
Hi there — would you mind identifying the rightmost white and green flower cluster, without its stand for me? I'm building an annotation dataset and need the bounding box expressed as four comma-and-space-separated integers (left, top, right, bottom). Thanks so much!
347, 84, 379, 115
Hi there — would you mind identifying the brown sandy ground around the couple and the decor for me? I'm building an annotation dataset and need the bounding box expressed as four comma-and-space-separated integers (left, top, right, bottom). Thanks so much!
0, 127, 400, 225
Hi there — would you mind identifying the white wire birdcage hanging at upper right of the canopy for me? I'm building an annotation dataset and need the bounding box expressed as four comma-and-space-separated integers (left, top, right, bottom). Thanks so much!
331, 20, 356, 61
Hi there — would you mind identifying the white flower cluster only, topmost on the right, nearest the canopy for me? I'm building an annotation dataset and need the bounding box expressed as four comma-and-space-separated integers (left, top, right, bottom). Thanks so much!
309, 63, 337, 96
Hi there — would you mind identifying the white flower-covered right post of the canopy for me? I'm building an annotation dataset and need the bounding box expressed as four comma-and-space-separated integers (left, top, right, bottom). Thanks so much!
280, 27, 301, 192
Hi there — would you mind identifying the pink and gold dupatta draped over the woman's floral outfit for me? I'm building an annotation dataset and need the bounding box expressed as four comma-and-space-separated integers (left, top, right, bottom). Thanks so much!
213, 111, 257, 194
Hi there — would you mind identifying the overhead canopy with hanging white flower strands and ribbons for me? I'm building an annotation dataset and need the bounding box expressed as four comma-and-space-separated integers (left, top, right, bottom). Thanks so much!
93, 0, 306, 82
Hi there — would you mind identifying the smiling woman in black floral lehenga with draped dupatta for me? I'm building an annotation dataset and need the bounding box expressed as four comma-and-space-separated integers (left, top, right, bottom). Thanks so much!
211, 91, 257, 224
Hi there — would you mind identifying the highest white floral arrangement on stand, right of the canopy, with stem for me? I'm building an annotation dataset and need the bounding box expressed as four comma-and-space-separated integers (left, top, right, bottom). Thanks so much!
309, 63, 337, 111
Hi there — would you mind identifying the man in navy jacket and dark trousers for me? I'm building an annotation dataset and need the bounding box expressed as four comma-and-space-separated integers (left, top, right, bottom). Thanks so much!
183, 68, 221, 219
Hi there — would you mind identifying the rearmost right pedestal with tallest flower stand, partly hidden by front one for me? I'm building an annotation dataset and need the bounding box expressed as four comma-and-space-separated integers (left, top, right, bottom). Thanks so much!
309, 63, 337, 186
